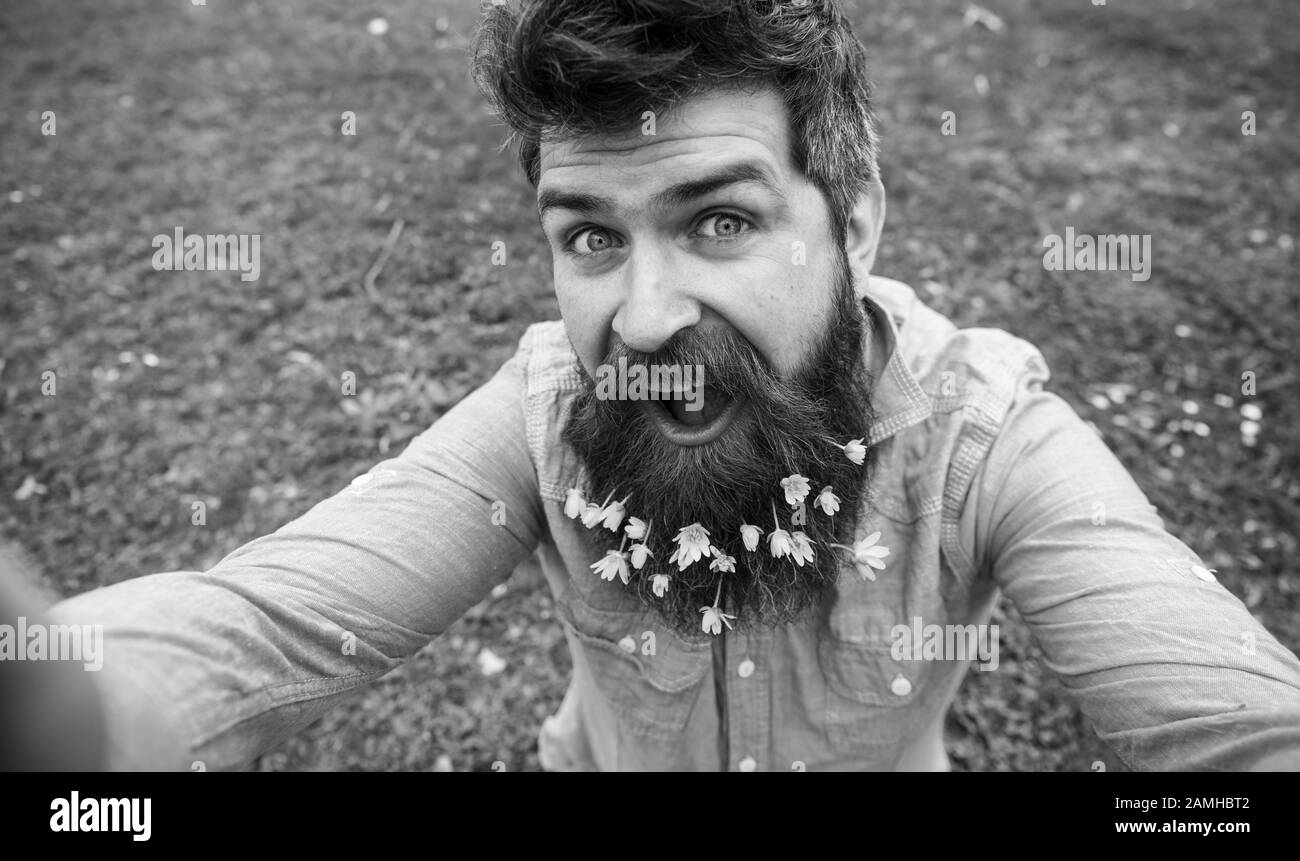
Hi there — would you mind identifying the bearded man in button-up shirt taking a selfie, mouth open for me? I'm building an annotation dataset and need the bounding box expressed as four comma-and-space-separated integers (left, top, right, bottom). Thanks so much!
40, 0, 1300, 771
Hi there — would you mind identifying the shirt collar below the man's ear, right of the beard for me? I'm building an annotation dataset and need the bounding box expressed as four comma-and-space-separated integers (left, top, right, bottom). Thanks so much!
854, 278, 933, 446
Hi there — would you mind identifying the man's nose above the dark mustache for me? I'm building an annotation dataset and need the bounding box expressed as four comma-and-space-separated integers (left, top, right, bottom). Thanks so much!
614, 246, 701, 352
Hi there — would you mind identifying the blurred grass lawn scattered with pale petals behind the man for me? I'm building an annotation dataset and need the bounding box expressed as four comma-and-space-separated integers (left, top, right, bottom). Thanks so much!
0, 0, 1300, 771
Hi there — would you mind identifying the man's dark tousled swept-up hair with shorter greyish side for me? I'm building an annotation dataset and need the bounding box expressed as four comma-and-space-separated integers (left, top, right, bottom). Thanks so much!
472, 0, 878, 239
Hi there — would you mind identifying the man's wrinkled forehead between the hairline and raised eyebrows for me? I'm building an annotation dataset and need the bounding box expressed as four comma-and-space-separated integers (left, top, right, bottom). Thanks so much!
538, 88, 793, 194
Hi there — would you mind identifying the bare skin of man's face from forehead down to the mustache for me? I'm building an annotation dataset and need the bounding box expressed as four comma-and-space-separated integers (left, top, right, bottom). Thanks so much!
538, 90, 839, 395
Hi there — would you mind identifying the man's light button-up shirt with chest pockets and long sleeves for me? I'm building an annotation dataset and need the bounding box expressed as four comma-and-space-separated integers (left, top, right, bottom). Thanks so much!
53, 277, 1300, 771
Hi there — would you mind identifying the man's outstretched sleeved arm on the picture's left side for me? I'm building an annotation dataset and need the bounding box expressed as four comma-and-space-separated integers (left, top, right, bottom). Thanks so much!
51, 355, 543, 770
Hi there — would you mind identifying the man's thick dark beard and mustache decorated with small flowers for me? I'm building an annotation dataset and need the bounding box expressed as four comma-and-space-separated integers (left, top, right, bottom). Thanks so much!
563, 261, 874, 636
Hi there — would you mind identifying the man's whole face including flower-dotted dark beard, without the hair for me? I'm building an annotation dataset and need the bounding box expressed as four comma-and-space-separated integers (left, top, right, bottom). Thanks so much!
538, 90, 870, 632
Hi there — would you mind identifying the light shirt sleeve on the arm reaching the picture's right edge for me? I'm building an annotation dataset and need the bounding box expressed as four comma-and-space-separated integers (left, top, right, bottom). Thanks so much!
962, 372, 1300, 770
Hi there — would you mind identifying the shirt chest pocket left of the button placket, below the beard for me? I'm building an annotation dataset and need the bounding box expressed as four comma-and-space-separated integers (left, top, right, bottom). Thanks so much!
556, 584, 712, 769
